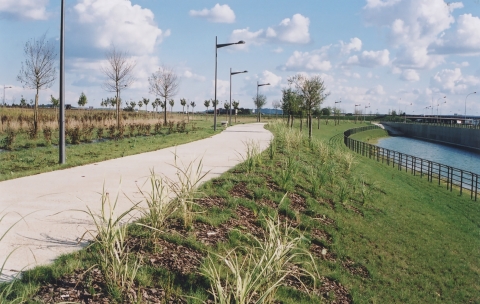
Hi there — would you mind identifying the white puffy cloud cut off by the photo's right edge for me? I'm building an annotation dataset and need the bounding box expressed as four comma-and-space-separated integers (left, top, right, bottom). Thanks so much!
431, 14, 480, 55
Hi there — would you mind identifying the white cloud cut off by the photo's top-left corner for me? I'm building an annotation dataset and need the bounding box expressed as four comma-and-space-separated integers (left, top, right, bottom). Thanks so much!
0, 0, 49, 20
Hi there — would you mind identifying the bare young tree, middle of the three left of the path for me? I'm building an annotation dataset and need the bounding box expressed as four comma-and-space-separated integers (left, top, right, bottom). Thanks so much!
102, 47, 136, 128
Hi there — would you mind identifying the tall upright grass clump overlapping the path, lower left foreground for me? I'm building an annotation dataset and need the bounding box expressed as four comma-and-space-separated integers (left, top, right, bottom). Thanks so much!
80, 190, 141, 291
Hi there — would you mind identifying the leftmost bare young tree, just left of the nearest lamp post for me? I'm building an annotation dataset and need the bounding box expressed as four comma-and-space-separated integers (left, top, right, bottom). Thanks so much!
17, 33, 57, 135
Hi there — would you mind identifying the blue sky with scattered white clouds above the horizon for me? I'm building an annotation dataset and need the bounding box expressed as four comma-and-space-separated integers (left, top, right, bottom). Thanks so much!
0, 0, 480, 115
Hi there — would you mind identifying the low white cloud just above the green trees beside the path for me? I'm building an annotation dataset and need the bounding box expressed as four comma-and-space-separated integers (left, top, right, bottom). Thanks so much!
283, 46, 332, 71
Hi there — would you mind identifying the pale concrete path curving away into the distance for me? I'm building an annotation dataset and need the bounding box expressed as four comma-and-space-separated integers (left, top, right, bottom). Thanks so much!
0, 123, 272, 279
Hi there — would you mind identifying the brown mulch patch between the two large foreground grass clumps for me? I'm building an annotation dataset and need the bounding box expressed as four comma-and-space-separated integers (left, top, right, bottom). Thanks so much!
149, 239, 203, 274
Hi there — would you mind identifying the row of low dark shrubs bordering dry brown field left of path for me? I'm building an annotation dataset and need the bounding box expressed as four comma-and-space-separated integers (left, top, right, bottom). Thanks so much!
0, 121, 197, 150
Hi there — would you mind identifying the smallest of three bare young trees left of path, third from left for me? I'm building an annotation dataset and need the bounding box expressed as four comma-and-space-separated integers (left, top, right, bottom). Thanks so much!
148, 66, 179, 125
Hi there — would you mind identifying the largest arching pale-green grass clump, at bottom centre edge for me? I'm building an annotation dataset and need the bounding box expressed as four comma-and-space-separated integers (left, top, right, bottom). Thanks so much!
201, 216, 319, 304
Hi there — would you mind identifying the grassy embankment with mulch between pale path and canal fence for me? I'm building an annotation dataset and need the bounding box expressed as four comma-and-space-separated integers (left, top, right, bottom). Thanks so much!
0, 120, 480, 303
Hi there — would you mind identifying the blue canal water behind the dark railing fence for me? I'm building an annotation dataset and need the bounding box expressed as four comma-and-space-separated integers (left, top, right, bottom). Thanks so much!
376, 136, 480, 174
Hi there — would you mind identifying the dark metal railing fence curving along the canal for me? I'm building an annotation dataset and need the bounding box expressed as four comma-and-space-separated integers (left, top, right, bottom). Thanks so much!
343, 126, 478, 201
